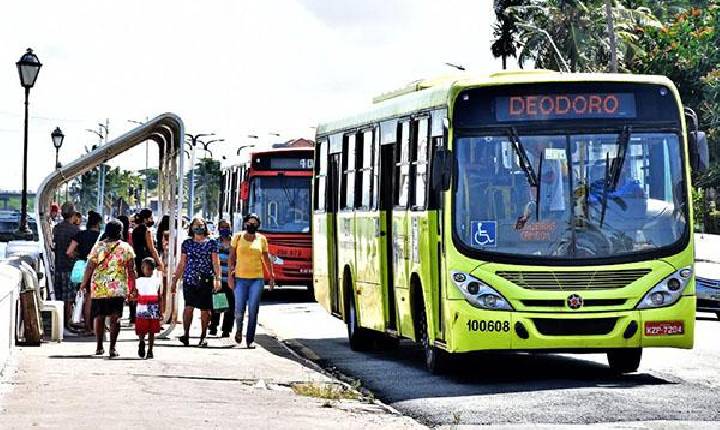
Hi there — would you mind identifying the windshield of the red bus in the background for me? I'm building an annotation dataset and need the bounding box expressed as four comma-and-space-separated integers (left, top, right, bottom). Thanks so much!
248, 176, 310, 233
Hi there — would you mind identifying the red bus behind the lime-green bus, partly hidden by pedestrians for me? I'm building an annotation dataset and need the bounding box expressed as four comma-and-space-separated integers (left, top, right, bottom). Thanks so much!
220, 147, 314, 289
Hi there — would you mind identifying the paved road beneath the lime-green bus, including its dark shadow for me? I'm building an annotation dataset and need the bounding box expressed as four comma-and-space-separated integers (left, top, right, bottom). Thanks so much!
260, 290, 720, 428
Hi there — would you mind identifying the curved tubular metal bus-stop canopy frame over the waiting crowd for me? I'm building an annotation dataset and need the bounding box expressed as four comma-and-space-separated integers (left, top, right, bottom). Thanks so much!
35, 113, 185, 328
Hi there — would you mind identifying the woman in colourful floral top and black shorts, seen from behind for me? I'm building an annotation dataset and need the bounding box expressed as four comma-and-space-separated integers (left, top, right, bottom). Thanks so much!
82, 221, 135, 358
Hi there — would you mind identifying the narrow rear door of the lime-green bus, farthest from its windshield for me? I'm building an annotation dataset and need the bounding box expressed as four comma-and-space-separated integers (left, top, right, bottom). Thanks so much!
327, 153, 342, 315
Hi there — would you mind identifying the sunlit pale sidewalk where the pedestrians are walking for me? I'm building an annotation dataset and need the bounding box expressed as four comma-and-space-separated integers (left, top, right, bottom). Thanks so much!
0, 312, 420, 430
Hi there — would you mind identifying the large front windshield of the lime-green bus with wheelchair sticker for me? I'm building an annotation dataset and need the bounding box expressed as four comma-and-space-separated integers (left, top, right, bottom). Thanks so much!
454, 129, 688, 259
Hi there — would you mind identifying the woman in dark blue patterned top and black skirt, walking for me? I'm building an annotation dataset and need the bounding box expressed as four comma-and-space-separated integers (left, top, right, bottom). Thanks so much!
172, 218, 221, 347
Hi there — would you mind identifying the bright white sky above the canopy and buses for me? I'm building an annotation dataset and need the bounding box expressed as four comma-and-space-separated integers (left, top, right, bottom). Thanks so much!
0, 0, 500, 190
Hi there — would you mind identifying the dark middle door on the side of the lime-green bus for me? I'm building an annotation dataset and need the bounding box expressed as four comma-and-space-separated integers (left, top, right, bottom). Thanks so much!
376, 133, 397, 330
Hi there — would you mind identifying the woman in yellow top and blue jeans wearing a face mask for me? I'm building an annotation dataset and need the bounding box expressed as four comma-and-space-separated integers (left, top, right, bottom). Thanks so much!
229, 214, 275, 348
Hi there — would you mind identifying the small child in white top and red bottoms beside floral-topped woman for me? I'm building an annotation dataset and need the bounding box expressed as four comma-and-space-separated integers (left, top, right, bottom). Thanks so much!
132, 257, 162, 360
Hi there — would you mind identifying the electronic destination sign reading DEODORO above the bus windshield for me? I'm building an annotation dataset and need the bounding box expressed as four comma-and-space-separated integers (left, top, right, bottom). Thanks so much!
495, 93, 637, 122
